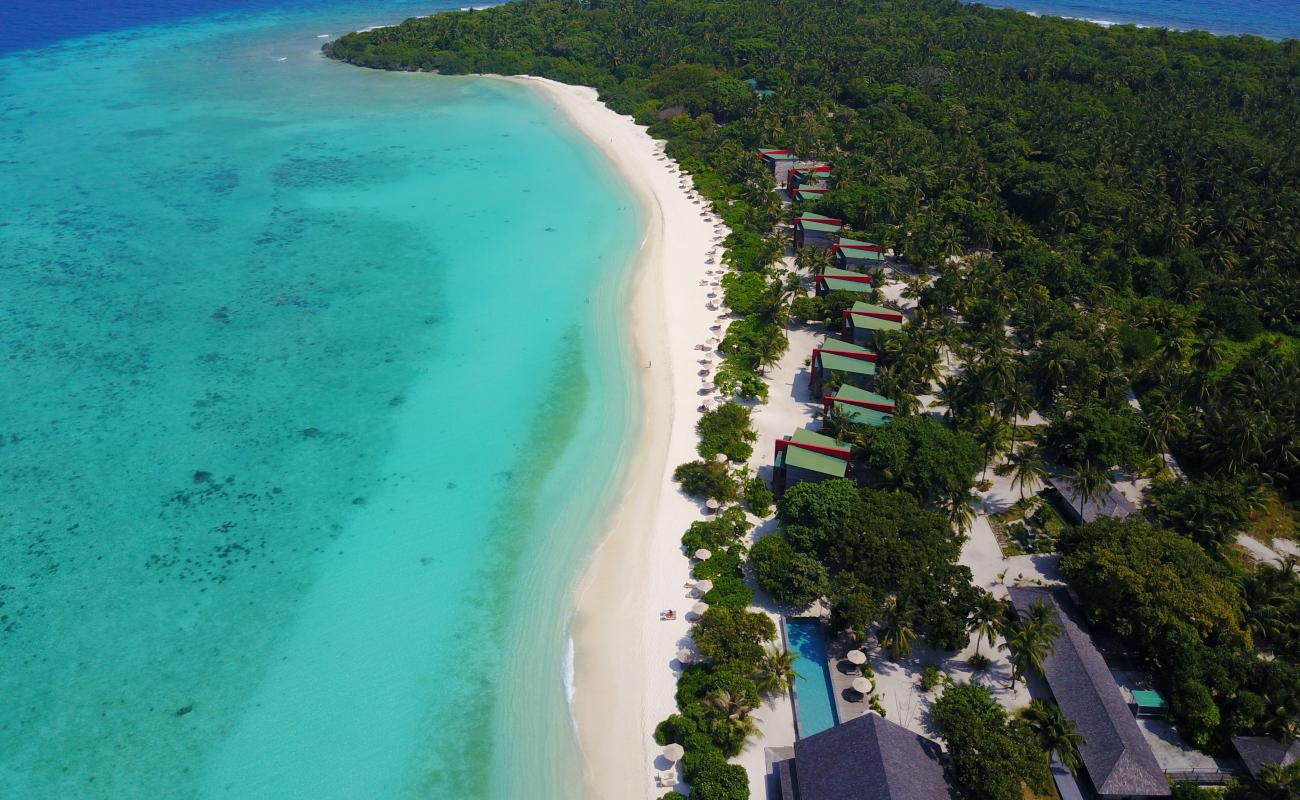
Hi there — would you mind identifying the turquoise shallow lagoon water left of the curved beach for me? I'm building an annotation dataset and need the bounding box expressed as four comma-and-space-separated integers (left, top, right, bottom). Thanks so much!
0, 3, 641, 800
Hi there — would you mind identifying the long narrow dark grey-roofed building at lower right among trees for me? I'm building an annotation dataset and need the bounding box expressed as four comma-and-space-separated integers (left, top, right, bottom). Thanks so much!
1010, 587, 1170, 799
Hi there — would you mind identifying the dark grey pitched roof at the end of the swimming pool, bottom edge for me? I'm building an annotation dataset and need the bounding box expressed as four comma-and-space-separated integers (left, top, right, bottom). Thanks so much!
771, 713, 956, 800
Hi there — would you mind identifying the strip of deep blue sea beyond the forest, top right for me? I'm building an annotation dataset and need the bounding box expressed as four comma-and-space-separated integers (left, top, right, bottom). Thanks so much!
982, 0, 1300, 39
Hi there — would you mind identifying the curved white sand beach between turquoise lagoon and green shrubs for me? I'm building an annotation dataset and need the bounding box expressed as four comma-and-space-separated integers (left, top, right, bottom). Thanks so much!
510, 77, 722, 800
